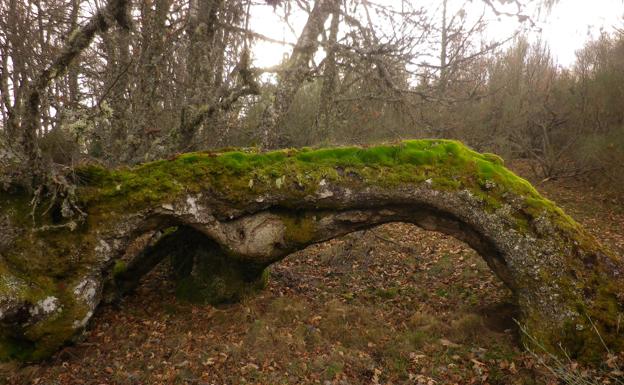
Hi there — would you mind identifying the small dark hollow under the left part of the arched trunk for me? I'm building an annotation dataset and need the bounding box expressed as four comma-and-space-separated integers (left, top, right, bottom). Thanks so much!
104, 225, 267, 304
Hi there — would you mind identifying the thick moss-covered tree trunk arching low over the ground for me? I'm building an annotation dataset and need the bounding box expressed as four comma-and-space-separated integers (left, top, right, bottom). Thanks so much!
0, 140, 624, 360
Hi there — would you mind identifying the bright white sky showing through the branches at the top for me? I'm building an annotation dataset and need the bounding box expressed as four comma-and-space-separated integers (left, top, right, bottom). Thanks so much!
251, 0, 624, 67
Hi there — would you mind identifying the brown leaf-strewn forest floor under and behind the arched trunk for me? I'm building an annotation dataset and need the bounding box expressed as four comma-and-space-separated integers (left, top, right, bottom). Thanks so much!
0, 163, 624, 385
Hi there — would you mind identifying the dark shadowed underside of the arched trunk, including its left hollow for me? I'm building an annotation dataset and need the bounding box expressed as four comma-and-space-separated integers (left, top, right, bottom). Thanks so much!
104, 205, 515, 312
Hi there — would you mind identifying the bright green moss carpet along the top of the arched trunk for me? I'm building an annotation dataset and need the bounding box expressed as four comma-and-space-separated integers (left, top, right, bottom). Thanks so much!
77, 139, 556, 216
